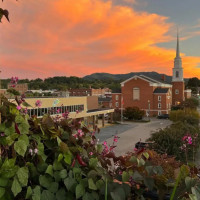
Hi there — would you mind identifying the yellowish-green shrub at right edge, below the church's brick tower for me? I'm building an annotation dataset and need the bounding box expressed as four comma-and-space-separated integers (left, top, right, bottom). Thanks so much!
169, 108, 199, 125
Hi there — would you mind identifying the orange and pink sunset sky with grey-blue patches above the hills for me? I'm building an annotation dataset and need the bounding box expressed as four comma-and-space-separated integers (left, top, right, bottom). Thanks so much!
0, 0, 200, 79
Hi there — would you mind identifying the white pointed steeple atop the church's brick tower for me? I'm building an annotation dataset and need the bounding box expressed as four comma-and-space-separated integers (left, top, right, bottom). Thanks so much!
172, 32, 183, 82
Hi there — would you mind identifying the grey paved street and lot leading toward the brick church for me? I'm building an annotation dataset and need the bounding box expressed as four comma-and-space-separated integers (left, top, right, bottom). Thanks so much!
96, 118, 171, 155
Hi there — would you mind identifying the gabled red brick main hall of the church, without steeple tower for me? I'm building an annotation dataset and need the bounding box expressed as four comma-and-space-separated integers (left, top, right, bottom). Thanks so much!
121, 75, 172, 116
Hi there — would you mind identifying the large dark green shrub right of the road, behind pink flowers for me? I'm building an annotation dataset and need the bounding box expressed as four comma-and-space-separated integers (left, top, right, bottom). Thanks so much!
148, 122, 200, 161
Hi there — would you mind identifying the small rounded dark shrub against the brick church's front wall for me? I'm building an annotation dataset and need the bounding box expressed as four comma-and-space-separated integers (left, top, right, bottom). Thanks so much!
123, 107, 144, 120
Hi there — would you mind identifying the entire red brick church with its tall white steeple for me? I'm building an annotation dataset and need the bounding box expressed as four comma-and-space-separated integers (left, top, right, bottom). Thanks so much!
112, 35, 191, 116
